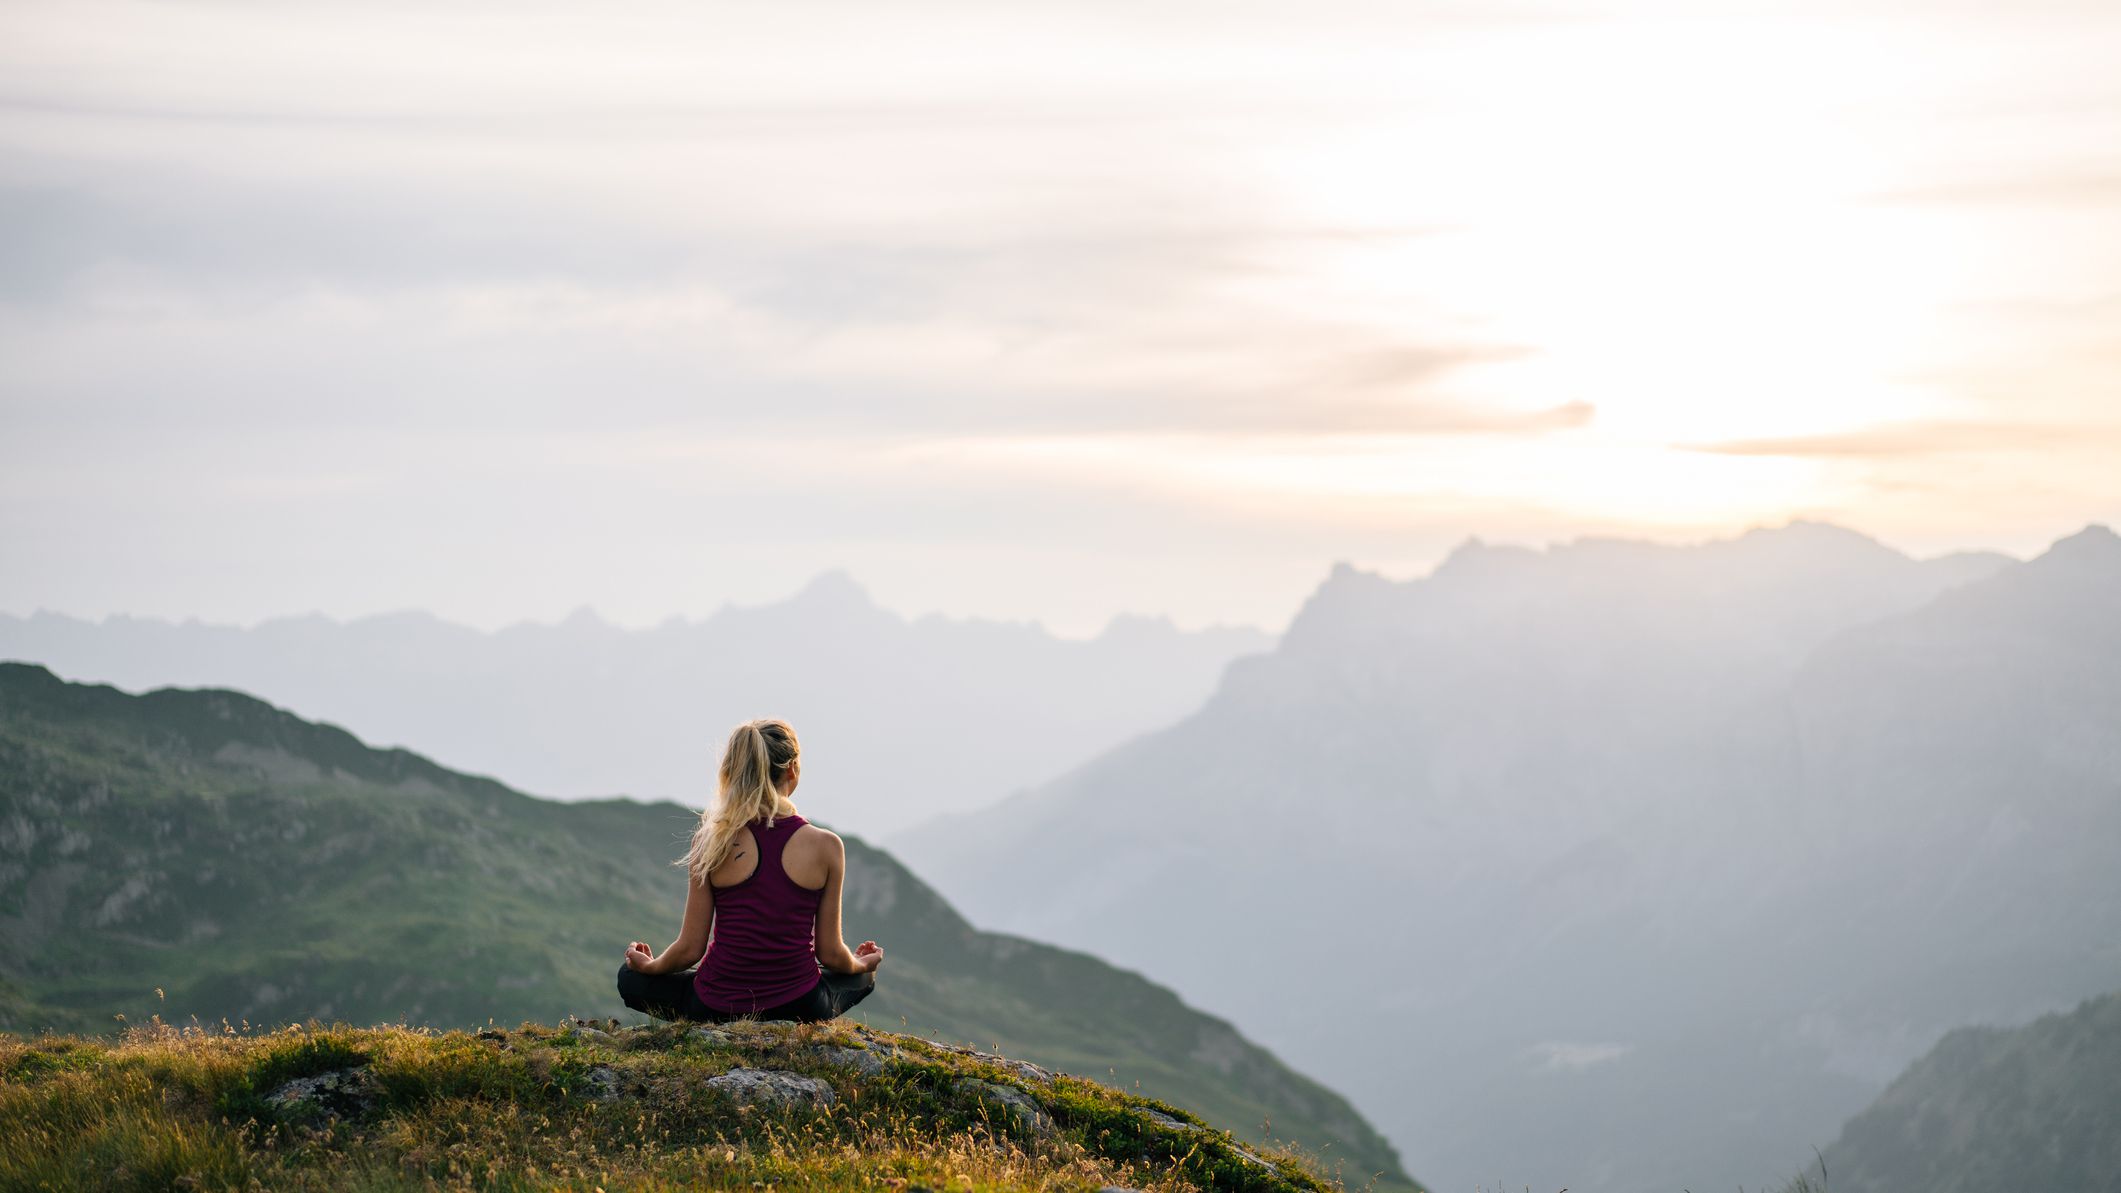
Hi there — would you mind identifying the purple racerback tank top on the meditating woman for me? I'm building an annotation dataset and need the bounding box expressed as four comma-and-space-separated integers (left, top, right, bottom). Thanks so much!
691, 815, 825, 1013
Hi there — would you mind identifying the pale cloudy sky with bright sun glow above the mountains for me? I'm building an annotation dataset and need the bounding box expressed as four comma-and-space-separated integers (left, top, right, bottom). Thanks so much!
0, 0, 2121, 635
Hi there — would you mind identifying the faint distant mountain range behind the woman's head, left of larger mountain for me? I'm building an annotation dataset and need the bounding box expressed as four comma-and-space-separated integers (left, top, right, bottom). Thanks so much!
0, 571, 1273, 834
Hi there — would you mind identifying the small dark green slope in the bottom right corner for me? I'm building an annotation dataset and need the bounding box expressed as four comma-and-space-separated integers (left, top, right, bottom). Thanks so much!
1811, 993, 2121, 1193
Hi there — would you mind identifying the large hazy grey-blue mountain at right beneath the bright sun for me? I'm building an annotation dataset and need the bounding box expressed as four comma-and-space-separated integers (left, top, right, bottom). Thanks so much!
893, 524, 2121, 1193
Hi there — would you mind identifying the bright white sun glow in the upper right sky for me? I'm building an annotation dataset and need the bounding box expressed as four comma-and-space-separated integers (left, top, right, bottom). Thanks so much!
1270, 21, 1960, 460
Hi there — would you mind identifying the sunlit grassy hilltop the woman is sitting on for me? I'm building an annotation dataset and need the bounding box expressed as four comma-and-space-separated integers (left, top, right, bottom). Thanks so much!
0, 1010, 1374, 1193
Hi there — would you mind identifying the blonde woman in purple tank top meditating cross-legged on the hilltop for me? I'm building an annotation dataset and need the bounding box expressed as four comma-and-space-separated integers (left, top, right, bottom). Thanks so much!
619, 720, 884, 1021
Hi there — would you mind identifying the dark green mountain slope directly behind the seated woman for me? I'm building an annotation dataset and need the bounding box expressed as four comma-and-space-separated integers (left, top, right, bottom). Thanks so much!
0, 664, 1404, 1182
